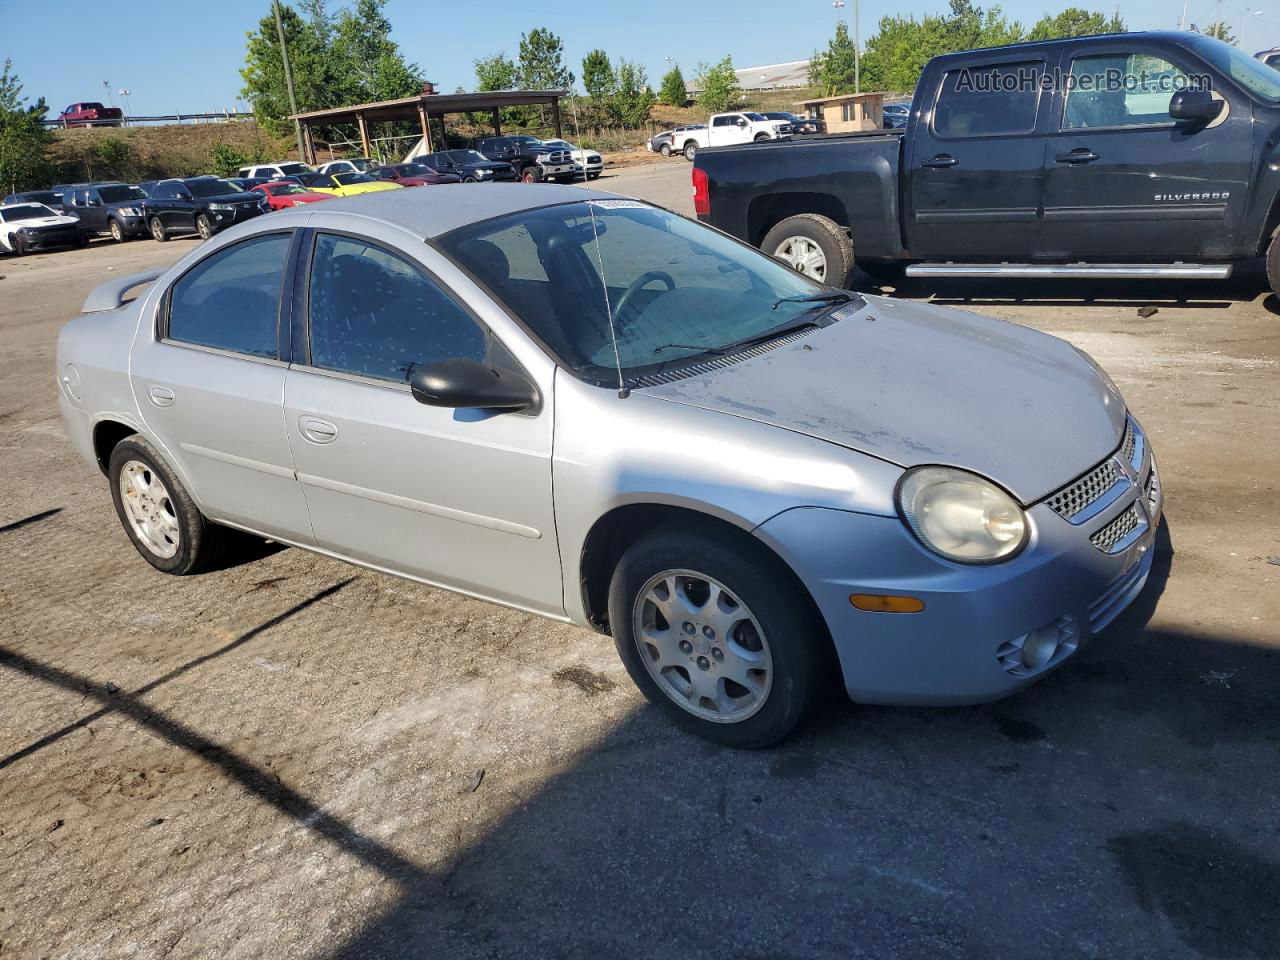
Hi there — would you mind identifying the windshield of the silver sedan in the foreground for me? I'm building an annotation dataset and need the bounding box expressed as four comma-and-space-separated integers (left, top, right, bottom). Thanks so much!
439, 200, 852, 384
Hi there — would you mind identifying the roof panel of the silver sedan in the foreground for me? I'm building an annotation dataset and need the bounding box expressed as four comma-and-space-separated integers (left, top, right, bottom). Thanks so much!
261, 183, 626, 239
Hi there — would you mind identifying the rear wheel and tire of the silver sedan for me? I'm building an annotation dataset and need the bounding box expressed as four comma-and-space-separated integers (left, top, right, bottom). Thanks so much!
106, 434, 227, 576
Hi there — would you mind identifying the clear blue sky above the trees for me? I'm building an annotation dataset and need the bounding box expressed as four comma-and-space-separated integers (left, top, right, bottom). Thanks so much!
0, 0, 1280, 116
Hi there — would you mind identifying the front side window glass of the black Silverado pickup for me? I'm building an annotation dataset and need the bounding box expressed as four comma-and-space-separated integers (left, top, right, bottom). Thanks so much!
1062, 51, 1190, 131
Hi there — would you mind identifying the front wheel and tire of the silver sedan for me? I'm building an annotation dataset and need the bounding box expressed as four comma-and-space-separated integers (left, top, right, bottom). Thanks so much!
609, 526, 831, 749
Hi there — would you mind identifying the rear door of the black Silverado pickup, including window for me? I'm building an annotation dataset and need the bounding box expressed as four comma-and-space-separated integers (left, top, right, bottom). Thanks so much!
904, 50, 1057, 260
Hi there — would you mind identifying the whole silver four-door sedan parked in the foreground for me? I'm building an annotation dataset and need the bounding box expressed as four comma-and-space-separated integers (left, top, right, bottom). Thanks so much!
58, 184, 1161, 746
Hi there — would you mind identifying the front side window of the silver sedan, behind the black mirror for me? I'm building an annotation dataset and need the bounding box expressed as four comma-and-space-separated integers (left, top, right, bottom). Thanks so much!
308, 234, 488, 383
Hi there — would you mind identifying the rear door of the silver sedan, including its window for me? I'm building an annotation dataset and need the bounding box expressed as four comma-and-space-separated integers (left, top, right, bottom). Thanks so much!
132, 230, 312, 544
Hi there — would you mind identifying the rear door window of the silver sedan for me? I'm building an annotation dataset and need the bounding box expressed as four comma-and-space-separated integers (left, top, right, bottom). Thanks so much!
168, 233, 292, 357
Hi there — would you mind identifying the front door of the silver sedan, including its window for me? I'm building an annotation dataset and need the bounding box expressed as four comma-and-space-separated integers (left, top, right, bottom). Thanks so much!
285, 232, 564, 616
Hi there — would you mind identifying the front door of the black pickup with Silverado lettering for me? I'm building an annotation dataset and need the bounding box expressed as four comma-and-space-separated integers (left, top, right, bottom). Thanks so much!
1044, 37, 1253, 261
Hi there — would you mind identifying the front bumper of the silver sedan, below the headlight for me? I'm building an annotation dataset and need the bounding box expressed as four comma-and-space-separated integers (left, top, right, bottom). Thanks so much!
756, 424, 1164, 704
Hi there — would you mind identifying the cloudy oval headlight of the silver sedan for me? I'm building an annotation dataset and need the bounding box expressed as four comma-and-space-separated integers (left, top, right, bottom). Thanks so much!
897, 466, 1029, 563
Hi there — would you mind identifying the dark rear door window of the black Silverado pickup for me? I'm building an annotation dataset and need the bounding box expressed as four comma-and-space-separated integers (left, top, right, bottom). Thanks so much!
933, 60, 1044, 138
